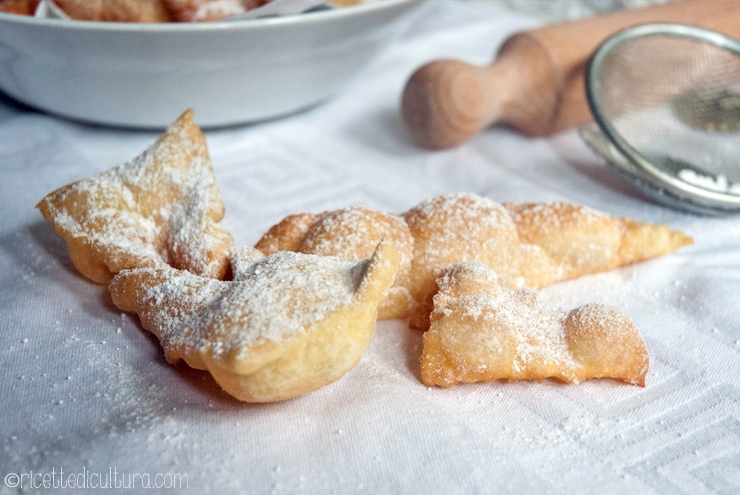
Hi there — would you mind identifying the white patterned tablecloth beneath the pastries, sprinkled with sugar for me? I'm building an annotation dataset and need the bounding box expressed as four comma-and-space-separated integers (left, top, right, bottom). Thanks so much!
0, 0, 740, 494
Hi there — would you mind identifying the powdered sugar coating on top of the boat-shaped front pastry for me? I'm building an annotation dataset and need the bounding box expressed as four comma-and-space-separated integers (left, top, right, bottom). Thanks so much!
137, 251, 368, 355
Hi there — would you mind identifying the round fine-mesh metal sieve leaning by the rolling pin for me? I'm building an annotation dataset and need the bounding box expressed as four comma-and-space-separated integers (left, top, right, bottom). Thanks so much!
581, 24, 740, 214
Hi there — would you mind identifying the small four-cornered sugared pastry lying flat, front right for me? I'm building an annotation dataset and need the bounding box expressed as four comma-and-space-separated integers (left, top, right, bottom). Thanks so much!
420, 262, 649, 387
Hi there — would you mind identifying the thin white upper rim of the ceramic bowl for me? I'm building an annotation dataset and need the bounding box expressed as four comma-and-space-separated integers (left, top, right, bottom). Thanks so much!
0, 0, 423, 33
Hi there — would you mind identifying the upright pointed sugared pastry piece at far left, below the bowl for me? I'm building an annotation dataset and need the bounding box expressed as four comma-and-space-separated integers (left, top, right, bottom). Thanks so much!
37, 110, 233, 283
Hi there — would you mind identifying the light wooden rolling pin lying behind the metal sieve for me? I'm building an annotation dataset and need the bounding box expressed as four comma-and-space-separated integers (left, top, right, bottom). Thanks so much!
401, 0, 740, 149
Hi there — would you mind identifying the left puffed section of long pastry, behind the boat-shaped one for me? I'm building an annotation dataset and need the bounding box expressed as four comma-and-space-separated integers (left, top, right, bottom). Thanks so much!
256, 206, 413, 319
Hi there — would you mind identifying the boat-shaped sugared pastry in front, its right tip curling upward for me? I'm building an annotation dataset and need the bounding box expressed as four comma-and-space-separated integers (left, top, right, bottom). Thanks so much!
109, 242, 399, 402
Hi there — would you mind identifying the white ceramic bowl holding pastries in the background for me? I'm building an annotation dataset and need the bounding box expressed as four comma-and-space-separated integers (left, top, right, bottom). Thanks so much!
0, 0, 421, 128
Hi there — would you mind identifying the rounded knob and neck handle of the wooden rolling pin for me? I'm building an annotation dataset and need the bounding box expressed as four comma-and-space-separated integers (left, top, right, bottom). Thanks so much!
401, 35, 562, 149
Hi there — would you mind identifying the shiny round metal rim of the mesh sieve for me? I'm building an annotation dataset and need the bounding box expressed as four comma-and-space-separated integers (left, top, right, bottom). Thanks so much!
585, 23, 740, 212
